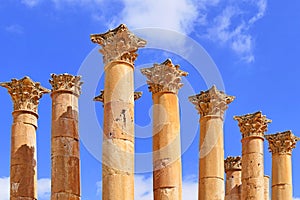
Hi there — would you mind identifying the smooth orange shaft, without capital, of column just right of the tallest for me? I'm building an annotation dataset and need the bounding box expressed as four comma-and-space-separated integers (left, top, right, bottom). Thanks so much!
153, 93, 182, 200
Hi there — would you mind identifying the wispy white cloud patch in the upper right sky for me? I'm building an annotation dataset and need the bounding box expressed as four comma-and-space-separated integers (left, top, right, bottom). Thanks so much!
202, 0, 267, 62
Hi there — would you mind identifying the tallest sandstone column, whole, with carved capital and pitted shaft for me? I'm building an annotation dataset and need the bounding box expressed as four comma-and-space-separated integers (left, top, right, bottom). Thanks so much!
91, 24, 146, 200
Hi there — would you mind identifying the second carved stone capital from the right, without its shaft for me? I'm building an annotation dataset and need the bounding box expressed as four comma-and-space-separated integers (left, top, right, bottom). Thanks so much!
234, 112, 272, 138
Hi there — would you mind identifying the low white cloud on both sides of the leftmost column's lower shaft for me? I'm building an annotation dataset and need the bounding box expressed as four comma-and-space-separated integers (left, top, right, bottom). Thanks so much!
0, 177, 51, 200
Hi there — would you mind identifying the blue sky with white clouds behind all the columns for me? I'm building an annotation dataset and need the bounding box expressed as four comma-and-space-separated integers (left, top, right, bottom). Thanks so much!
0, 0, 300, 200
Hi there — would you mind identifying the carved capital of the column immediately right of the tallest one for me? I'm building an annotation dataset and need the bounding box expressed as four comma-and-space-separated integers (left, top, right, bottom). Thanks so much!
141, 59, 188, 94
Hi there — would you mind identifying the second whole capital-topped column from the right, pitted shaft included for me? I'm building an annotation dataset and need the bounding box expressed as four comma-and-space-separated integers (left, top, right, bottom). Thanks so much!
234, 112, 271, 200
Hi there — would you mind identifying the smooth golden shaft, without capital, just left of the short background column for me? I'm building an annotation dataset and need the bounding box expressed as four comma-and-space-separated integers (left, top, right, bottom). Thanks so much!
199, 116, 225, 200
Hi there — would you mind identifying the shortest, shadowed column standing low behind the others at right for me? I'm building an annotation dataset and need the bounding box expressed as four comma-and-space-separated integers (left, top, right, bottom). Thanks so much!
224, 156, 242, 200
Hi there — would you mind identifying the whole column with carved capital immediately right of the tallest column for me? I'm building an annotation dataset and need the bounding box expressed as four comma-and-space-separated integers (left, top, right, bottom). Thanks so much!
141, 59, 187, 200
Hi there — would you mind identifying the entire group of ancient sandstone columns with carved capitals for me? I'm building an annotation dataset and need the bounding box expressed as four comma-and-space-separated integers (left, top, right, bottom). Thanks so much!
0, 24, 300, 200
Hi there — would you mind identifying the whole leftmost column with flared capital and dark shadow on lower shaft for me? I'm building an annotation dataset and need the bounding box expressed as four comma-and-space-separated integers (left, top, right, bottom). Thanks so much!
0, 77, 50, 200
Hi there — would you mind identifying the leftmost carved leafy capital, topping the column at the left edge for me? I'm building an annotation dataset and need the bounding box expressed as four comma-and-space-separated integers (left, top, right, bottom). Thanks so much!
0, 76, 50, 113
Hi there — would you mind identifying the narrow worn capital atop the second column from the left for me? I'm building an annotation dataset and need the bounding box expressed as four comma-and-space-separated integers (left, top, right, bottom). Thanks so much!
49, 74, 82, 96
